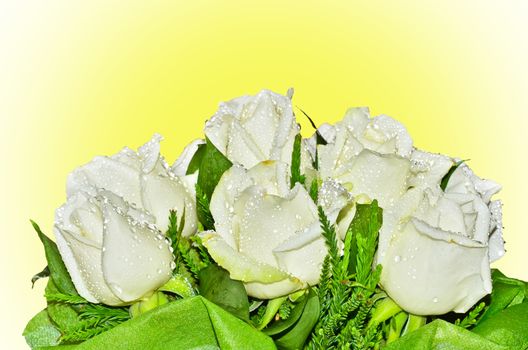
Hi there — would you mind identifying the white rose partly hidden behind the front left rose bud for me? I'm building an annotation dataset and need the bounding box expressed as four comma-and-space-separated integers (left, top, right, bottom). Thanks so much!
66, 135, 197, 236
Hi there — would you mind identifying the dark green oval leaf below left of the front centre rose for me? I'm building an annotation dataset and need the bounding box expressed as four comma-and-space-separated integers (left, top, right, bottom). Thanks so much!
199, 264, 249, 321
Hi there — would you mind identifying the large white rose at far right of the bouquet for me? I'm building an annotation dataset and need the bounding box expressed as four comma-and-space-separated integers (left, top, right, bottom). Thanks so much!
377, 156, 504, 315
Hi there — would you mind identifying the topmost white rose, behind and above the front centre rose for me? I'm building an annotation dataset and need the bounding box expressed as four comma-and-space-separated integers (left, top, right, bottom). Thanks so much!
205, 90, 310, 169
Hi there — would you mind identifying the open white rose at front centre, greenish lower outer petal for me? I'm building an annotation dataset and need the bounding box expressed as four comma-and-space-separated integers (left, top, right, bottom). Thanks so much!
201, 161, 348, 299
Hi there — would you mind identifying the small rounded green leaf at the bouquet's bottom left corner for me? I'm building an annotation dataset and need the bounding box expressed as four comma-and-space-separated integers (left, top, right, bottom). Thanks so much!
22, 309, 61, 349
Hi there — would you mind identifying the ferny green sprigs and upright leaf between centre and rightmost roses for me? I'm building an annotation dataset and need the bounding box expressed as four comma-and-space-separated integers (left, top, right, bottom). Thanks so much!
307, 201, 382, 349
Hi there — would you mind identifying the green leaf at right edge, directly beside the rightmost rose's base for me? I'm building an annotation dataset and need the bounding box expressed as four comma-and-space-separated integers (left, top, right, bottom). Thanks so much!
479, 269, 528, 322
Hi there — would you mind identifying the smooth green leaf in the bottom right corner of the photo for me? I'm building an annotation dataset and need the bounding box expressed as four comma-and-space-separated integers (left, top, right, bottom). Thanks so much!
472, 303, 528, 349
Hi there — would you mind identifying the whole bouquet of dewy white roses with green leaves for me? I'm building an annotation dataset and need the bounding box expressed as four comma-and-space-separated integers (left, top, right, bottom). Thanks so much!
24, 90, 528, 350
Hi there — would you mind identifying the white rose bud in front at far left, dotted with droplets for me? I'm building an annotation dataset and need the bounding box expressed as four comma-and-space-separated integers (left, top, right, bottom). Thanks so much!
54, 189, 174, 305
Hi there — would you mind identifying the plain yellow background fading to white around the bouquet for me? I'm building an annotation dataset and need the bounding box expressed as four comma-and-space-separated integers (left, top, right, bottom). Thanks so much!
0, 0, 528, 349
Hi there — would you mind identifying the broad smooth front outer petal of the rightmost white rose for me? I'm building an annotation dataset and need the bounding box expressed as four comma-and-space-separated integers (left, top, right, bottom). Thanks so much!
381, 220, 491, 315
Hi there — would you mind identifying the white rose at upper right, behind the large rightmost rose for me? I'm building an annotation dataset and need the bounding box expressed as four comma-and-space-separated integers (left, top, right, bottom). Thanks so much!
318, 108, 412, 208
